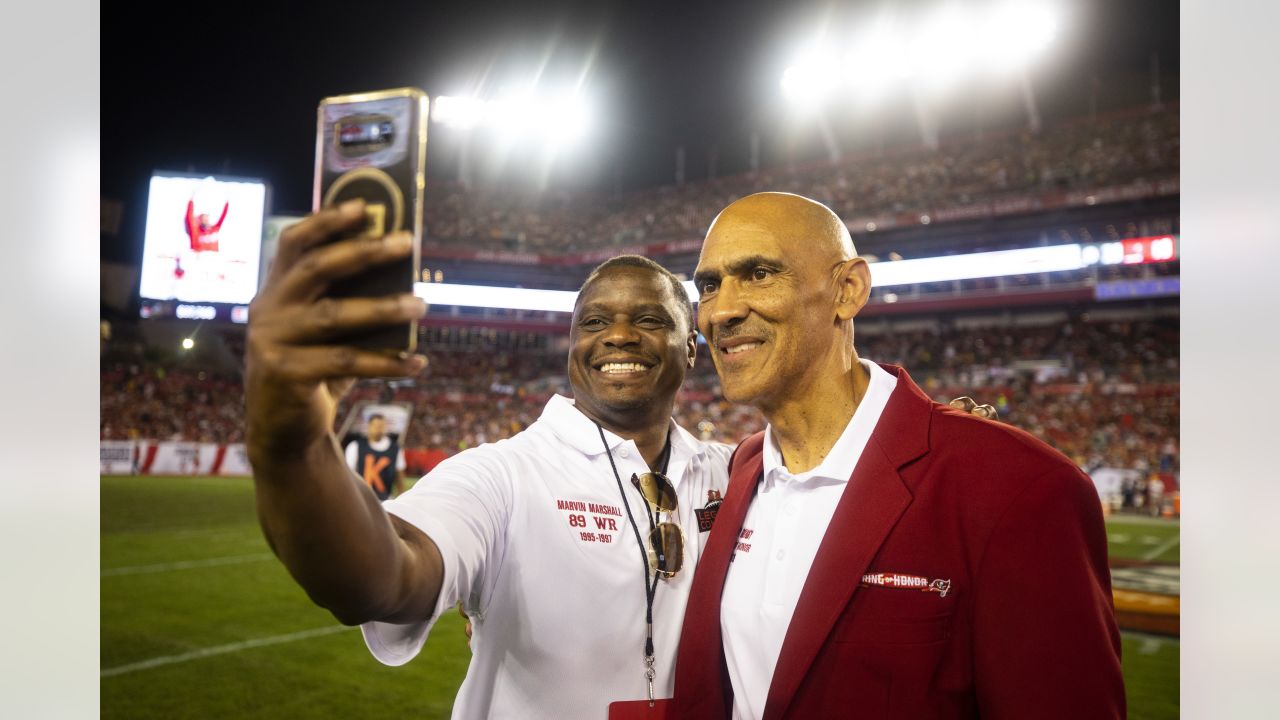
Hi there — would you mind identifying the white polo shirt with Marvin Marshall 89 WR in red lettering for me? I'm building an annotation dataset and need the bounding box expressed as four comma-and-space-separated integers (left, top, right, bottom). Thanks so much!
362, 396, 732, 720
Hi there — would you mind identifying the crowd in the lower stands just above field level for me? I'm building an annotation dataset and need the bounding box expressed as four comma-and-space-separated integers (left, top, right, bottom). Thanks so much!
101, 319, 1179, 486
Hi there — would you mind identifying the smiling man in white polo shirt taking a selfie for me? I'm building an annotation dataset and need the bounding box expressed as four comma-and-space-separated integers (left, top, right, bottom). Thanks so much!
246, 199, 730, 719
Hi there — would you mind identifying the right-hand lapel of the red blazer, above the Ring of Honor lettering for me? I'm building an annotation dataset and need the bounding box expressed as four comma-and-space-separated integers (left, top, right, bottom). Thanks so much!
764, 366, 929, 720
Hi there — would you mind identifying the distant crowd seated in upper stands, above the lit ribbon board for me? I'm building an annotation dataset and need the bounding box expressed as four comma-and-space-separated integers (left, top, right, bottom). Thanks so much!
428, 108, 1179, 252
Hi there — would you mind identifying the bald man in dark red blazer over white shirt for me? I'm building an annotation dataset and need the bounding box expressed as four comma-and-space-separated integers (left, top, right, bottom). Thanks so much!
675, 192, 1125, 720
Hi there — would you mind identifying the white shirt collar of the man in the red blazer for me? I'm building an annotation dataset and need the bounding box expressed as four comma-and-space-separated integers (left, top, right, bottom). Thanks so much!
760, 359, 897, 491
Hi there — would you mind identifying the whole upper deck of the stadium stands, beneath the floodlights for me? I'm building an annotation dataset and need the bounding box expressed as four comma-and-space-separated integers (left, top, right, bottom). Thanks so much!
428, 106, 1179, 258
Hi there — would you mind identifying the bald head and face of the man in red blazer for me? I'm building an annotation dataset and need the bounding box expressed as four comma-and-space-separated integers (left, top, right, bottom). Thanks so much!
694, 192, 870, 412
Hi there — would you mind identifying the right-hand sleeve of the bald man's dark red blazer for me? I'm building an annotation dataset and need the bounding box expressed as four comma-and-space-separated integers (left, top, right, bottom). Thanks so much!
973, 468, 1125, 720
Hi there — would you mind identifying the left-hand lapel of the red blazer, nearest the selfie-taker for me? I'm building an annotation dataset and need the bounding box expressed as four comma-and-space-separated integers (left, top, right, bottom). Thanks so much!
675, 433, 764, 720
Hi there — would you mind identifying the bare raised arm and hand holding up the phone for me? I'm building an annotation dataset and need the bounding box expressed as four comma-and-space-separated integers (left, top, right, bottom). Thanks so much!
244, 201, 443, 624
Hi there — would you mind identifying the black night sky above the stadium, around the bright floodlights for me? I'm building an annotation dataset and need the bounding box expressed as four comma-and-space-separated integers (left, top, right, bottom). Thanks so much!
101, 0, 1179, 261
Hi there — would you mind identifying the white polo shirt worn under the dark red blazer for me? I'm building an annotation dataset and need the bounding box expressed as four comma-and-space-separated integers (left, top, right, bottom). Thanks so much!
721, 360, 897, 720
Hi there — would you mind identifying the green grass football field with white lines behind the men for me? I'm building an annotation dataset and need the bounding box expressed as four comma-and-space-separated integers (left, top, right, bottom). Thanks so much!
101, 477, 1179, 720
